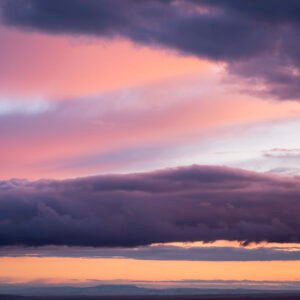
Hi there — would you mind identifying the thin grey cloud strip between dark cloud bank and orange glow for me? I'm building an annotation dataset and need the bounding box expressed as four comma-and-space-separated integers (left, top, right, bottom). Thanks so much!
0, 244, 300, 261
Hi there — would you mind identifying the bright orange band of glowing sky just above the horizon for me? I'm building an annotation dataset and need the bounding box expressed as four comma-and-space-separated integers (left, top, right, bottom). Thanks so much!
0, 257, 300, 282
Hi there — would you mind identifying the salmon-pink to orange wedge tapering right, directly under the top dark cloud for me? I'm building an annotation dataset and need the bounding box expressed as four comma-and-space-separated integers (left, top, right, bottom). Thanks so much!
0, 27, 211, 98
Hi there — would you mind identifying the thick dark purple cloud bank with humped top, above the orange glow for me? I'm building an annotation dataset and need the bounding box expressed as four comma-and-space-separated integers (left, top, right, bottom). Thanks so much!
0, 166, 300, 247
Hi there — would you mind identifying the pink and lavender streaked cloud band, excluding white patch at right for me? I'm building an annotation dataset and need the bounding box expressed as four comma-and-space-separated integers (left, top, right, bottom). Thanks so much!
0, 78, 298, 178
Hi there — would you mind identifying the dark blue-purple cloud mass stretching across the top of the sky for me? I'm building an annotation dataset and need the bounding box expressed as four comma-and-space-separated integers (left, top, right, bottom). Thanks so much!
0, 0, 300, 100
